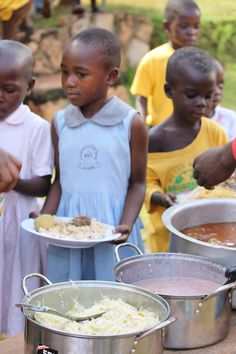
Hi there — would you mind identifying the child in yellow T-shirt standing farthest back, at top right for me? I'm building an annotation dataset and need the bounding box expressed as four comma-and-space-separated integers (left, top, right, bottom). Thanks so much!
131, 0, 200, 126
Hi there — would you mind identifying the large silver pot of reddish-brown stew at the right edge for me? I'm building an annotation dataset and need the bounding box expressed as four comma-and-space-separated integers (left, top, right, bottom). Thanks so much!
162, 199, 236, 309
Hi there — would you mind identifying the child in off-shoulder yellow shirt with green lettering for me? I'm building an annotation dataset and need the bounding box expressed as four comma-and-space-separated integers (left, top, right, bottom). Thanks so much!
146, 47, 227, 252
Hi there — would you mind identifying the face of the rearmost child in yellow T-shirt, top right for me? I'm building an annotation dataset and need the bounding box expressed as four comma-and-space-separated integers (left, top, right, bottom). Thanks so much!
164, 9, 200, 49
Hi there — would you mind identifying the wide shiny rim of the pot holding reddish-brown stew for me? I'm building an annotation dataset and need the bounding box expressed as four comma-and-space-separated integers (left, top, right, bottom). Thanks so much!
162, 198, 236, 251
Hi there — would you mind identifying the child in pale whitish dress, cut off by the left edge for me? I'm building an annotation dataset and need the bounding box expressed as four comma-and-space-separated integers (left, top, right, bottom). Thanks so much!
0, 40, 53, 335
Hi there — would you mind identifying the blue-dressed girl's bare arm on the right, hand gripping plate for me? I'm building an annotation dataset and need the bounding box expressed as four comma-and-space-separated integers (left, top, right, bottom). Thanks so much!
115, 115, 148, 242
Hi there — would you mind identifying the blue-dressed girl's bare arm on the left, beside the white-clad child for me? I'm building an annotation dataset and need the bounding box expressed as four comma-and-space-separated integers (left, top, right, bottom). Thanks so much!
41, 122, 61, 215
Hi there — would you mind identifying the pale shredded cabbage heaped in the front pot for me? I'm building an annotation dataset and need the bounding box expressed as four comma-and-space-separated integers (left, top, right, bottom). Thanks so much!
34, 297, 160, 335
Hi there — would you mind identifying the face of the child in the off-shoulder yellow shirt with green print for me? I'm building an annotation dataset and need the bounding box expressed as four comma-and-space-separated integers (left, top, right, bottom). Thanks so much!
170, 67, 216, 124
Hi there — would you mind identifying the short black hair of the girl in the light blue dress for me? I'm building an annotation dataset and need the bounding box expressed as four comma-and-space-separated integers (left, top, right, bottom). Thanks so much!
68, 28, 121, 68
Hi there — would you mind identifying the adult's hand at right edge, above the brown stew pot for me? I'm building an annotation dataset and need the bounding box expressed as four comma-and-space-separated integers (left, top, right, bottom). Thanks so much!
193, 138, 236, 189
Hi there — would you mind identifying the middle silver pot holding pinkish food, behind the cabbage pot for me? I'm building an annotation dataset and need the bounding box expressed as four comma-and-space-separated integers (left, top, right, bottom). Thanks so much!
114, 243, 236, 349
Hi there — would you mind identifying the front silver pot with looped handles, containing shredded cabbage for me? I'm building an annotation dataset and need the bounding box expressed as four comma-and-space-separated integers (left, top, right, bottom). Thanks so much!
22, 273, 175, 354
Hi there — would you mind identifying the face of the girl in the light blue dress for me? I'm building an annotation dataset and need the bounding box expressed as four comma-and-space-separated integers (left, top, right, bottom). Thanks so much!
61, 42, 115, 114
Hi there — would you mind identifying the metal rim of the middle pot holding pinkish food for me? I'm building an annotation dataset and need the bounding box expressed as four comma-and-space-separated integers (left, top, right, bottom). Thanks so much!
113, 252, 227, 302
